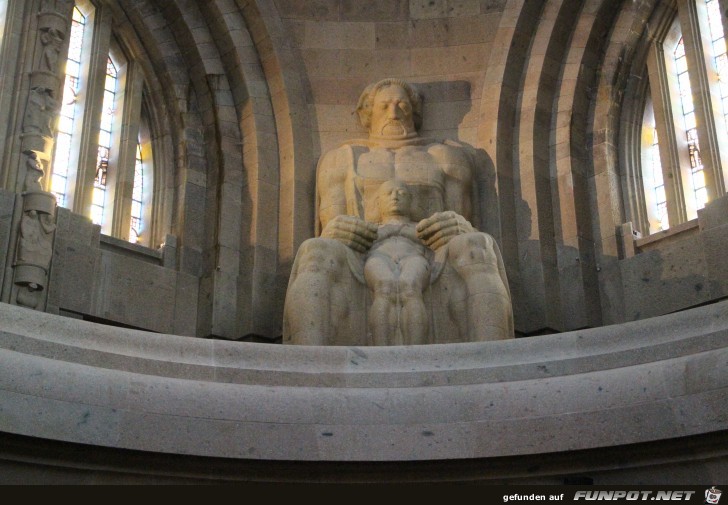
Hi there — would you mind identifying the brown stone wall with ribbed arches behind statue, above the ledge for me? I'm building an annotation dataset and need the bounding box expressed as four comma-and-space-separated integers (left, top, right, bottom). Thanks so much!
0, 0, 728, 341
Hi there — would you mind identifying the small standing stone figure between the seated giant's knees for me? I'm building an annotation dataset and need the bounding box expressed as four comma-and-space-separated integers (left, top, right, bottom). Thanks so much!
364, 179, 432, 345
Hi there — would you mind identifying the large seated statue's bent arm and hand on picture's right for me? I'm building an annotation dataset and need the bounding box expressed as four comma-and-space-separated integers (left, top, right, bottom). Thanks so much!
417, 144, 475, 250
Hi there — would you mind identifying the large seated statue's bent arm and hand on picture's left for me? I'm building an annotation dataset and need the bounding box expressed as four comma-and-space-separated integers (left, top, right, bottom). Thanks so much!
316, 147, 377, 252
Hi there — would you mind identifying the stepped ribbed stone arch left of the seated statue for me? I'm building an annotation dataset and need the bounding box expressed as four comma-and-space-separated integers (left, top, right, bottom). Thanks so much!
86, 1, 314, 338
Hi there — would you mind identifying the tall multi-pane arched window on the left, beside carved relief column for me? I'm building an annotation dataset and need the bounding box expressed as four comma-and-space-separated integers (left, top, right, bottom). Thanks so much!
50, 0, 153, 245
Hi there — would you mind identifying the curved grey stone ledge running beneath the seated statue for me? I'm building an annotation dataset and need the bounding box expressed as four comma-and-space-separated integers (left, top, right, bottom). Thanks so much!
0, 301, 728, 461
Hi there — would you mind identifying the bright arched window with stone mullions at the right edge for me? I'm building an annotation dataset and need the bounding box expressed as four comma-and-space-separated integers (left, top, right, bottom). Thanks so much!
632, 0, 728, 234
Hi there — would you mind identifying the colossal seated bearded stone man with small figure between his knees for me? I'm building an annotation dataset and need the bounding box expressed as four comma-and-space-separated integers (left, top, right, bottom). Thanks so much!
283, 79, 513, 345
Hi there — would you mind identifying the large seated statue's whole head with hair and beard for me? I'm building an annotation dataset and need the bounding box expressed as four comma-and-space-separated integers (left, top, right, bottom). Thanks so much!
356, 78, 422, 139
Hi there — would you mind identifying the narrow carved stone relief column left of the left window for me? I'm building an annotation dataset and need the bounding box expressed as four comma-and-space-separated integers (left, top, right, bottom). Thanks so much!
10, 0, 73, 310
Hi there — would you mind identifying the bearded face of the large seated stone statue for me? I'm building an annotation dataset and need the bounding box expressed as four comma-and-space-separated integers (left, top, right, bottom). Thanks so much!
369, 85, 415, 139
